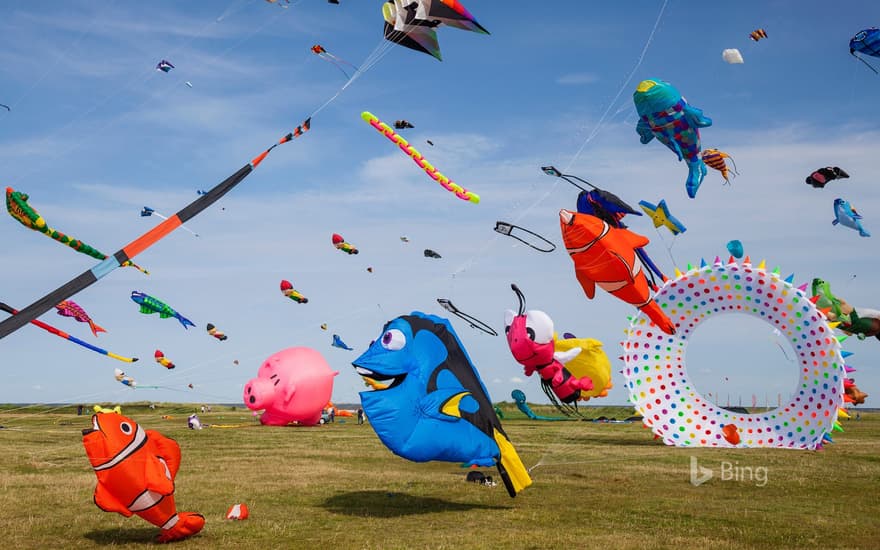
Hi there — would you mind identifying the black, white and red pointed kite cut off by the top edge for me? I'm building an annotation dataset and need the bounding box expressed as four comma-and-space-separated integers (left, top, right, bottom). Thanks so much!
382, 0, 489, 61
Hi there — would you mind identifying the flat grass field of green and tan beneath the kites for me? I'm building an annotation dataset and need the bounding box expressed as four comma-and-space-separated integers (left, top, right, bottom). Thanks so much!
0, 405, 880, 549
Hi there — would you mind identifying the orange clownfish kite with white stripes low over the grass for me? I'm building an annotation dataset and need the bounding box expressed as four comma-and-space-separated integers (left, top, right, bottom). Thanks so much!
82, 413, 205, 542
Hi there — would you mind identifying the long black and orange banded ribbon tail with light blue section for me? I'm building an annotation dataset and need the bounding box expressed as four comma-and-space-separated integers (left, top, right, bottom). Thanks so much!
0, 117, 312, 339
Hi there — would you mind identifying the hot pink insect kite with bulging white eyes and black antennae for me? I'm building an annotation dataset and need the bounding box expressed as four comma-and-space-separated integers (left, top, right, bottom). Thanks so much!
504, 284, 593, 414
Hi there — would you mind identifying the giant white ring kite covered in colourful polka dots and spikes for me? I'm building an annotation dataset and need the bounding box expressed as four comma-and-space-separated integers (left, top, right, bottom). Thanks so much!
623, 257, 846, 449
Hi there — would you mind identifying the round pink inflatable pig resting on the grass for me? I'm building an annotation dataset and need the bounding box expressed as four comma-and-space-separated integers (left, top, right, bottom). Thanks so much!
244, 347, 339, 426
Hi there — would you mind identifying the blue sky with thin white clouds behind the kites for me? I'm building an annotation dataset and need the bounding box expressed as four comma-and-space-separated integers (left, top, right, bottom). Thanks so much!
0, 0, 880, 405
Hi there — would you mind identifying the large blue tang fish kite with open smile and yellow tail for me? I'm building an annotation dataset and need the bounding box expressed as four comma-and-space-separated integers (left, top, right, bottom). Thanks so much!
352, 311, 532, 497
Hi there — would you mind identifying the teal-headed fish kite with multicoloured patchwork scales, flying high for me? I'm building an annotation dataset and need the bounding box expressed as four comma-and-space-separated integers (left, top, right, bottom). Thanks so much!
633, 78, 712, 198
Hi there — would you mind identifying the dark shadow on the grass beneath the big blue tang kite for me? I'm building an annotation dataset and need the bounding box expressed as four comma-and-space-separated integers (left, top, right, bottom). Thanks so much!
321, 491, 509, 518
